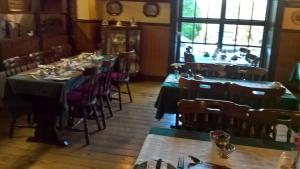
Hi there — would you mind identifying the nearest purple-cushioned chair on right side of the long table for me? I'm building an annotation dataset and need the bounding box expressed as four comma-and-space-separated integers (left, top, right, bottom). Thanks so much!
67, 66, 106, 144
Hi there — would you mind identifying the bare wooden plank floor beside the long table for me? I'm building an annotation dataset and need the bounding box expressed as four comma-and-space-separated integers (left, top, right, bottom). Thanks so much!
0, 82, 174, 169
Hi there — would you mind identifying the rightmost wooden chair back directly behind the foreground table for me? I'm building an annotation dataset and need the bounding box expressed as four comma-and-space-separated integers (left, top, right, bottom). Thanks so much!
250, 109, 292, 142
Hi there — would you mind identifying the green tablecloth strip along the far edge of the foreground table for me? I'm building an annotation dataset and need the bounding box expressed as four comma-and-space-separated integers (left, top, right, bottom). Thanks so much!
149, 128, 295, 151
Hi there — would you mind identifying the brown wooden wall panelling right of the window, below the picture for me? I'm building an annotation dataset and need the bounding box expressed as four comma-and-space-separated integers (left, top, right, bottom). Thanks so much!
275, 31, 300, 87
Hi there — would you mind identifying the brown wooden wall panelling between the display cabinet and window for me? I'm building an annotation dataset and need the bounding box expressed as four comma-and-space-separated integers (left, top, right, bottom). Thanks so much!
141, 25, 170, 77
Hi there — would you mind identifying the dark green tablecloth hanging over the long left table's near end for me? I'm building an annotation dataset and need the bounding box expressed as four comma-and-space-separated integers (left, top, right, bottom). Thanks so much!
5, 72, 84, 115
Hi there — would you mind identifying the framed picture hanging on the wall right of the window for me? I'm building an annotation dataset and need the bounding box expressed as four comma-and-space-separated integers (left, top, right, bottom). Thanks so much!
281, 7, 300, 30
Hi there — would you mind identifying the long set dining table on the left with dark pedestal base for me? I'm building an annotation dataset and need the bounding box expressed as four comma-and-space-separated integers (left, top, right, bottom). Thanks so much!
5, 53, 111, 146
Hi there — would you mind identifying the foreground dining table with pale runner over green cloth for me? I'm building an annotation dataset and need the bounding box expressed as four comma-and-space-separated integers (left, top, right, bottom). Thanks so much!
135, 128, 300, 169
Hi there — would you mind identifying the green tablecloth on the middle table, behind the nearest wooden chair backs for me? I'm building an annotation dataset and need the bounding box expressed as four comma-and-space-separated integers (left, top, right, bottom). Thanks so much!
155, 74, 298, 119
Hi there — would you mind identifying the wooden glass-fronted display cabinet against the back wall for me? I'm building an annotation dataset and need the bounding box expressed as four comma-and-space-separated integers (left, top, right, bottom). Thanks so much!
101, 26, 142, 74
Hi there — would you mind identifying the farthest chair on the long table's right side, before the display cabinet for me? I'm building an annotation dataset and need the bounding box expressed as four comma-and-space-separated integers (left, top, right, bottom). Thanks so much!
112, 51, 136, 110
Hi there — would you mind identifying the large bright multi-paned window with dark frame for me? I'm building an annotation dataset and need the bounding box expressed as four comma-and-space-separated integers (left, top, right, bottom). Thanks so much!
178, 0, 269, 62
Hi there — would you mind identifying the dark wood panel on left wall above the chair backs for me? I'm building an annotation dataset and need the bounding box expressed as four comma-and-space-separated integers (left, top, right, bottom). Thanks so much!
0, 37, 39, 59
